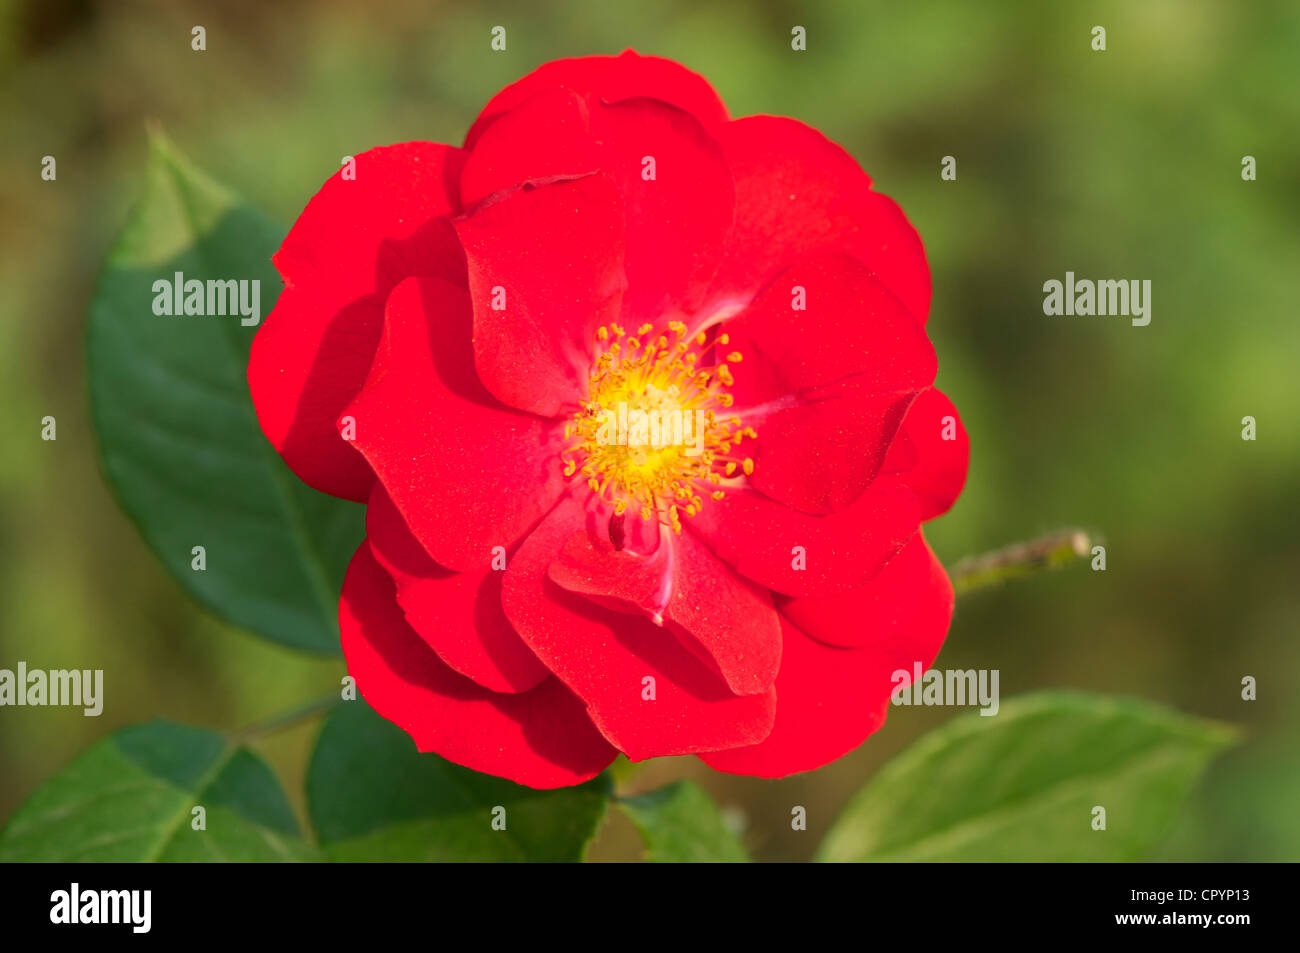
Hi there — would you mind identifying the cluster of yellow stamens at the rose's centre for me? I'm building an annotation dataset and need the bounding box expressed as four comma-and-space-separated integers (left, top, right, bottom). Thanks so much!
560, 321, 758, 533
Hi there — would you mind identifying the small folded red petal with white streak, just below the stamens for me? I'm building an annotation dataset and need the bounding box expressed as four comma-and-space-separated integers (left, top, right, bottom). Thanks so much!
550, 511, 781, 694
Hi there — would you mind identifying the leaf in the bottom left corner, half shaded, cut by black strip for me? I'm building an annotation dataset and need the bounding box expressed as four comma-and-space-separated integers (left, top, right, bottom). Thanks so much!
0, 720, 315, 862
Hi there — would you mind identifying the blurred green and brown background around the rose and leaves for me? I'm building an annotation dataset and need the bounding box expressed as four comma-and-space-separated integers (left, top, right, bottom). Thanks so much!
0, 0, 1300, 861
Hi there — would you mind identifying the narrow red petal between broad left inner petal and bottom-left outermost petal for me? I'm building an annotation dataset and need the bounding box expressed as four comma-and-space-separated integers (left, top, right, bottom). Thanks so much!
365, 485, 550, 692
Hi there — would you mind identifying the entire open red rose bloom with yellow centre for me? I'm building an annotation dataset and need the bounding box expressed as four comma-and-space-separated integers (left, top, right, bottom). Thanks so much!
248, 51, 967, 788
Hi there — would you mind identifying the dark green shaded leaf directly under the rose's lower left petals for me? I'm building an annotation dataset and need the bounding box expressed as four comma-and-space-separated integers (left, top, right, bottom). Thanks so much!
307, 701, 610, 861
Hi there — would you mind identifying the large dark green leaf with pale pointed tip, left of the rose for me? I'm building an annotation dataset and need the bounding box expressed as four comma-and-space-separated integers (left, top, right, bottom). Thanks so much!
87, 137, 364, 653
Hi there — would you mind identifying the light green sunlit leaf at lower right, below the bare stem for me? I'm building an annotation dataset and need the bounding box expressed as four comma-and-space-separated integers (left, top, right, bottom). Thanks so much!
818, 692, 1236, 861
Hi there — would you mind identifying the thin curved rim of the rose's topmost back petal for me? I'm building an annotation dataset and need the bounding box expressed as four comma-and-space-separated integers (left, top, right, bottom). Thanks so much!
465, 49, 727, 148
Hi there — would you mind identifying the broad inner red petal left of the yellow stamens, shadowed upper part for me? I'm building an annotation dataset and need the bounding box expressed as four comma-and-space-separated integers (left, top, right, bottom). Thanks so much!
348, 278, 563, 571
